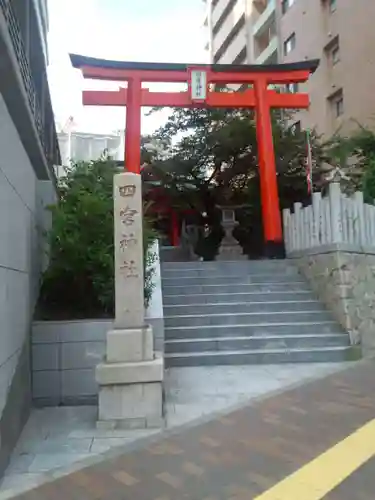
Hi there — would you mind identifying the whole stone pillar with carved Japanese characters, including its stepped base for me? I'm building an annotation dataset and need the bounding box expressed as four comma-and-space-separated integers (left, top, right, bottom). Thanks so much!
96, 172, 164, 428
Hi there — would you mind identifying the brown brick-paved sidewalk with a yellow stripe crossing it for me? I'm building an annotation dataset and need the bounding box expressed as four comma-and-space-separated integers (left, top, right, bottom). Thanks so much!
8, 363, 375, 500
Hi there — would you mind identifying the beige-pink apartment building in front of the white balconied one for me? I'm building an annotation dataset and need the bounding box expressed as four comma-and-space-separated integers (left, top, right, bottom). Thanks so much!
277, 0, 375, 137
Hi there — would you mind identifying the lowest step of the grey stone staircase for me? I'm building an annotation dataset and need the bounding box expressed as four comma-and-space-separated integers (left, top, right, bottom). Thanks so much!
165, 346, 352, 370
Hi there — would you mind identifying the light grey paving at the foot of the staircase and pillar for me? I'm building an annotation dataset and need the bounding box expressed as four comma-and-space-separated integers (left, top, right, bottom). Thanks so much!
0, 364, 363, 498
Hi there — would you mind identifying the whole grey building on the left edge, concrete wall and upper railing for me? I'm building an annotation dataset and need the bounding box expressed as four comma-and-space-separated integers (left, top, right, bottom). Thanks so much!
0, 0, 60, 477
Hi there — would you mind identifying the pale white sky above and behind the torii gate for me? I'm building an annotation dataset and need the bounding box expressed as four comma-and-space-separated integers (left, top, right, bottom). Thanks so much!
48, 0, 208, 134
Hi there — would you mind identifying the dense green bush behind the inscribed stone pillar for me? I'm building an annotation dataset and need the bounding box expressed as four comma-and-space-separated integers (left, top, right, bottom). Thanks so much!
38, 157, 155, 319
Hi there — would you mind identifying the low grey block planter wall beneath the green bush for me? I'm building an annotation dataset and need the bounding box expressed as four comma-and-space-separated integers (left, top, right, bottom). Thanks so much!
32, 243, 164, 406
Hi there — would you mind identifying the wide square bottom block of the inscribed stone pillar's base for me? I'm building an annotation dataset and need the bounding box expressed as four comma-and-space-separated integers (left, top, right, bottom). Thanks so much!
96, 354, 164, 429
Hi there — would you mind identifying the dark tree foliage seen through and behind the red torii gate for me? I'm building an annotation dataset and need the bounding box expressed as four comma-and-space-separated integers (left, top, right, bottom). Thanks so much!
142, 104, 323, 256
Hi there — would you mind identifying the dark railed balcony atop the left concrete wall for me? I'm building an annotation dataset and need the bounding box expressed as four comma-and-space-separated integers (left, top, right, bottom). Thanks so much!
0, 0, 60, 179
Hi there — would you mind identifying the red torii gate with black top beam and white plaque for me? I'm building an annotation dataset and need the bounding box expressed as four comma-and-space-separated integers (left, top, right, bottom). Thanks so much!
70, 54, 319, 256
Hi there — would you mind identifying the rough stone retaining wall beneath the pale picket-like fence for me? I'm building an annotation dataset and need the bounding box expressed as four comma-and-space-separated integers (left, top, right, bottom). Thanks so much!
289, 244, 375, 356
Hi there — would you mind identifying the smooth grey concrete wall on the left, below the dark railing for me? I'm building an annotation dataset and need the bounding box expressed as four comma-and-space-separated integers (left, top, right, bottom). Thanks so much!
0, 95, 54, 475
